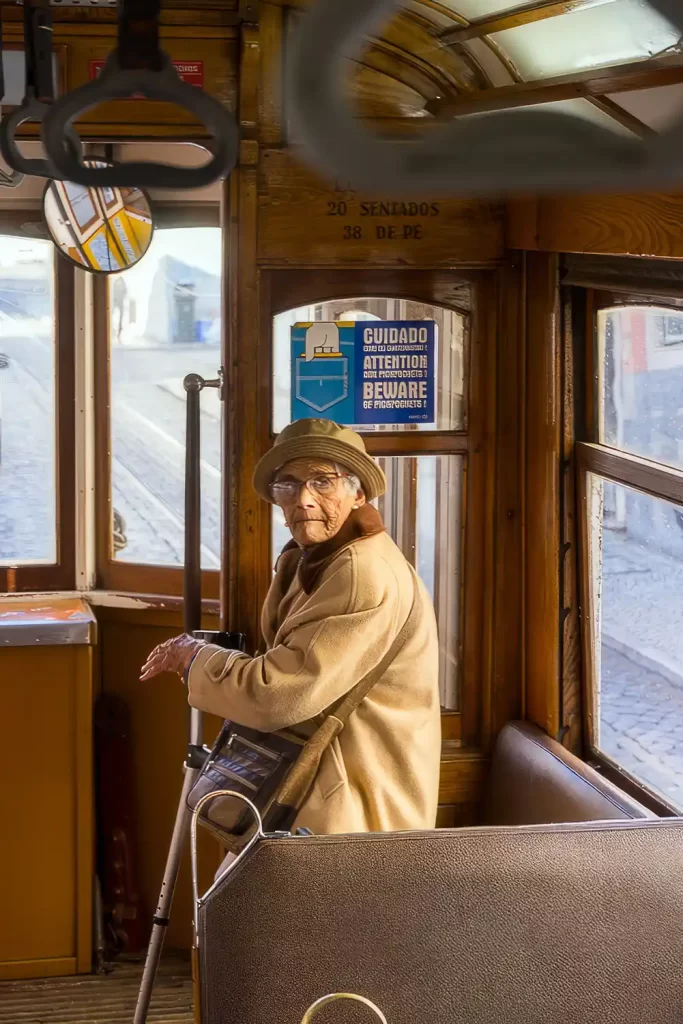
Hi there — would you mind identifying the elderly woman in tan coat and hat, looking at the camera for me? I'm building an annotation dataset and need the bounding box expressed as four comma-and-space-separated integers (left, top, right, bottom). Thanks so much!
141, 420, 441, 835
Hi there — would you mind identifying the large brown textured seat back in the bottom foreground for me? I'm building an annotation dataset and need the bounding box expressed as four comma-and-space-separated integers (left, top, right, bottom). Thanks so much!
199, 819, 683, 1024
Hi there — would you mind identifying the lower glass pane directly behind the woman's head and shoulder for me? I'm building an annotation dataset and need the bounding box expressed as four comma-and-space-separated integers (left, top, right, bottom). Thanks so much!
272, 456, 463, 711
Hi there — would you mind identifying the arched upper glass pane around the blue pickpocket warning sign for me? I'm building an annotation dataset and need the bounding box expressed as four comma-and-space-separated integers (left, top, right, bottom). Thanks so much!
272, 298, 467, 433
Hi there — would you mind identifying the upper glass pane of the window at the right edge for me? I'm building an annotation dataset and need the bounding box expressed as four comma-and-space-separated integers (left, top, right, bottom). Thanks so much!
598, 306, 683, 468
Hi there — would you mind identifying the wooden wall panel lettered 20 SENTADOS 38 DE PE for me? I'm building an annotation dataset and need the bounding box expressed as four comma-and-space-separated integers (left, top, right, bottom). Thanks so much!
258, 150, 504, 267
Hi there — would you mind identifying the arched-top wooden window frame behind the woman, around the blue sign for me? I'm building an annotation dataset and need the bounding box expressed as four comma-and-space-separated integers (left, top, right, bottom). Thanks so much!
236, 268, 500, 746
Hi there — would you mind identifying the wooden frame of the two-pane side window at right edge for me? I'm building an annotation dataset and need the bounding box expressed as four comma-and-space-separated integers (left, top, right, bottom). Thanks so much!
575, 280, 683, 817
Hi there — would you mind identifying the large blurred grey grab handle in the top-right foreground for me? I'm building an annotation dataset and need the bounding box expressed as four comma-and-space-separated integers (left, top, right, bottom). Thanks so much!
288, 0, 683, 196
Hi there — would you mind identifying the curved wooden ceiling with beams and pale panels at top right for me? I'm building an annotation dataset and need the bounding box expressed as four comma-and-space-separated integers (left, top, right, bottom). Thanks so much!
270, 0, 683, 136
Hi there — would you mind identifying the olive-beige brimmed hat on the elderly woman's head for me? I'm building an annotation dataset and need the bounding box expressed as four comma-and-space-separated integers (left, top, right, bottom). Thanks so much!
254, 420, 387, 502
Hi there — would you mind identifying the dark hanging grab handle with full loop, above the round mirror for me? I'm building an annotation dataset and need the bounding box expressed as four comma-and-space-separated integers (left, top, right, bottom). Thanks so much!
42, 0, 239, 189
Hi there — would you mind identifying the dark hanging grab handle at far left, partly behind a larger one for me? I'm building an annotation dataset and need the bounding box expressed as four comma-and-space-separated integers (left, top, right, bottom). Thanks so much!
0, 0, 79, 180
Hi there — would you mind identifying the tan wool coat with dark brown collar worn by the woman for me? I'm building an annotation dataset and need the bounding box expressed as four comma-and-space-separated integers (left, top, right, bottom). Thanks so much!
188, 506, 441, 835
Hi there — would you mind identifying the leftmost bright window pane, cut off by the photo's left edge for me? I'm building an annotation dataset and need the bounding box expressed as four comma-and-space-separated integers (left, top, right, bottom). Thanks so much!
0, 236, 57, 565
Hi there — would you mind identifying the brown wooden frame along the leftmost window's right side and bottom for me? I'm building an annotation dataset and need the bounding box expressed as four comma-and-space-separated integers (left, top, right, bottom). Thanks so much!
0, 249, 76, 593
